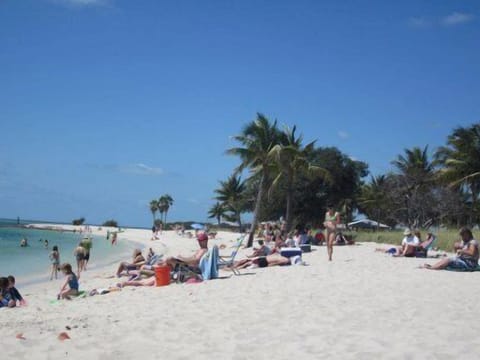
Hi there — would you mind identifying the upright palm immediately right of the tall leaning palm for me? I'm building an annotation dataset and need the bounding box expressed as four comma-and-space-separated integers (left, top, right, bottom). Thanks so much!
269, 126, 329, 231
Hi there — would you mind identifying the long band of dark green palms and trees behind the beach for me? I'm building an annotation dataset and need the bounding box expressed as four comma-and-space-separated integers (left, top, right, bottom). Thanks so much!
209, 114, 480, 246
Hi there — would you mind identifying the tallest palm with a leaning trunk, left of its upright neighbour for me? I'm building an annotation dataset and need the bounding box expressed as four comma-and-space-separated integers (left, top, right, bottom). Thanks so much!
227, 113, 279, 247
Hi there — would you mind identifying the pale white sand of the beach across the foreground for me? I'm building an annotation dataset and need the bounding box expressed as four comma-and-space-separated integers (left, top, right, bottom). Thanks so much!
0, 229, 480, 360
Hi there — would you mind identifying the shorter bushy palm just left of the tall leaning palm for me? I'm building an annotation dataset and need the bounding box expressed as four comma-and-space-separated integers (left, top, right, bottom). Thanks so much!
215, 175, 246, 228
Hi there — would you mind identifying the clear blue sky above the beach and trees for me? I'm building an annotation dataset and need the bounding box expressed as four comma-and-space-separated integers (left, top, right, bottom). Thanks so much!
0, 0, 480, 226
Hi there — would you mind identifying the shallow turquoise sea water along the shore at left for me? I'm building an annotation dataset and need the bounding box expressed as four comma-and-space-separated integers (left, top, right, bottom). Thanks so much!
0, 219, 136, 285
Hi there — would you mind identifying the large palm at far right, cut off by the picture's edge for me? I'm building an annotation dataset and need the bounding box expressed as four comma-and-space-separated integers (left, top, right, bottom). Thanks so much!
435, 123, 480, 223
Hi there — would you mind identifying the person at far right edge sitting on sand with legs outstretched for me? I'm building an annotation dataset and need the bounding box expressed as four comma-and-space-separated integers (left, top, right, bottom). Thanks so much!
422, 227, 479, 271
